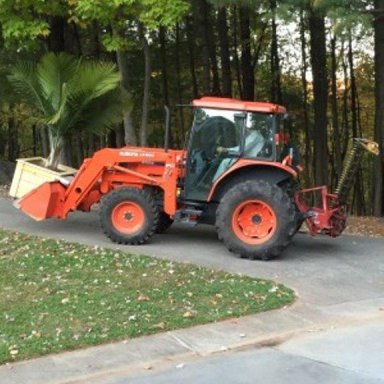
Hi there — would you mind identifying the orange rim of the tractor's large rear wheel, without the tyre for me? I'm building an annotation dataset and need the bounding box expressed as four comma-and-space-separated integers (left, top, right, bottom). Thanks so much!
232, 200, 277, 244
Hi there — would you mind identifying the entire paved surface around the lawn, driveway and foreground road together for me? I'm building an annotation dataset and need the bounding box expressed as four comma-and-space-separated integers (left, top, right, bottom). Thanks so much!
0, 199, 384, 384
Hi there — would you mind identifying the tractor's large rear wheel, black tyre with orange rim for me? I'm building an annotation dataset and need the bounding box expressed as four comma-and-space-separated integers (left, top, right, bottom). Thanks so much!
216, 180, 296, 260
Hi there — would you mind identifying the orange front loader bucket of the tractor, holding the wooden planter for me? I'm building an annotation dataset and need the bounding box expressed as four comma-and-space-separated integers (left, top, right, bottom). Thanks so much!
15, 181, 66, 221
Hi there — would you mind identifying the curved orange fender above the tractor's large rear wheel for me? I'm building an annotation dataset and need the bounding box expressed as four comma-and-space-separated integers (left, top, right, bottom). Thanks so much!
208, 159, 297, 202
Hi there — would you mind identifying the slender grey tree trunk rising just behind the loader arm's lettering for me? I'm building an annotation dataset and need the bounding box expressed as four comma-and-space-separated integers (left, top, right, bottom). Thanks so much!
138, 23, 151, 147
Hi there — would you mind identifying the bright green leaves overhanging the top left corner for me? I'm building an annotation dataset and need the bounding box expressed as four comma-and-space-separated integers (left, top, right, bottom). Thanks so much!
0, 0, 189, 50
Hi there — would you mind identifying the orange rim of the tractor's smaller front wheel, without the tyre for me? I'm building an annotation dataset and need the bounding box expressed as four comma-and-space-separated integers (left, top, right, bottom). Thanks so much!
111, 201, 145, 234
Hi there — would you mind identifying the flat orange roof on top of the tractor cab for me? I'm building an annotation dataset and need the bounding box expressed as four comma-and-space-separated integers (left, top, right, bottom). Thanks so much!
192, 97, 287, 113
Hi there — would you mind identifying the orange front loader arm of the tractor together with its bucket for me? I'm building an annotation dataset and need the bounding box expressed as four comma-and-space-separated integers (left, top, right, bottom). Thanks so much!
19, 147, 183, 220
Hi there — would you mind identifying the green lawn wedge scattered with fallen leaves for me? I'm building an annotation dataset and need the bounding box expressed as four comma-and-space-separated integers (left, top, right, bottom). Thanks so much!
0, 230, 294, 363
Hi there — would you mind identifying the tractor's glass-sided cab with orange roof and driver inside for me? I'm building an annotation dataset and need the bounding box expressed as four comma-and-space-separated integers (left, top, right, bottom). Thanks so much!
184, 97, 286, 201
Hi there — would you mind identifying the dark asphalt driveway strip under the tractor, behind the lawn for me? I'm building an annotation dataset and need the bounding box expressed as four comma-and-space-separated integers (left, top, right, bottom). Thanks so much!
0, 198, 384, 306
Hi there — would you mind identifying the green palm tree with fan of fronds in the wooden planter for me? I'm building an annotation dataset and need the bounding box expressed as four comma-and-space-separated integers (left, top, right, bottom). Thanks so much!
9, 53, 123, 169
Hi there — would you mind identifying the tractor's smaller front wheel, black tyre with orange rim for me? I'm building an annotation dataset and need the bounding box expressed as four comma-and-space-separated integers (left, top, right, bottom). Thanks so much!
100, 187, 159, 245
